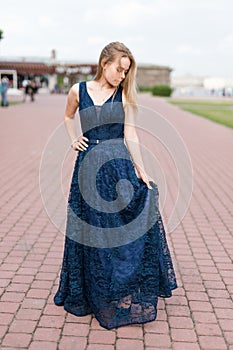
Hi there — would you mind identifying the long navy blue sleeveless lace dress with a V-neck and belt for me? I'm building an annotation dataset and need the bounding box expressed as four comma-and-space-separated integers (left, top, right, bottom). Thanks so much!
54, 82, 177, 329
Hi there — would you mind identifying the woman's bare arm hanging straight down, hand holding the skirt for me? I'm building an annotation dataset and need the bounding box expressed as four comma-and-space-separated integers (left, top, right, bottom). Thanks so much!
124, 97, 152, 189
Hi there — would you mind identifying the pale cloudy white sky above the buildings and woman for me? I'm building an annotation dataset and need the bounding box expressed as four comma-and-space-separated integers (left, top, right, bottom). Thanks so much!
0, 0, 233, 78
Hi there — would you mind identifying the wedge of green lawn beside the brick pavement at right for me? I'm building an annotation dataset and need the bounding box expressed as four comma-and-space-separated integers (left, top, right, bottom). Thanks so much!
167, 99, 233, 128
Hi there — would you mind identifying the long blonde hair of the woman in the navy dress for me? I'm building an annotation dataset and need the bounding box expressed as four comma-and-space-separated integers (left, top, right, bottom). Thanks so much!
94, 41, 137, 107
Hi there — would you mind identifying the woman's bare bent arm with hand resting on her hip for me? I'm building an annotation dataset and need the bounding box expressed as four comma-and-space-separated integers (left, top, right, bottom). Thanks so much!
65, 84, 88, 151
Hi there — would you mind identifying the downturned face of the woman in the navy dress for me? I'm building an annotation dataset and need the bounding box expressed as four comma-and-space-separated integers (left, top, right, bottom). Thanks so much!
103, 57, 130, 87
